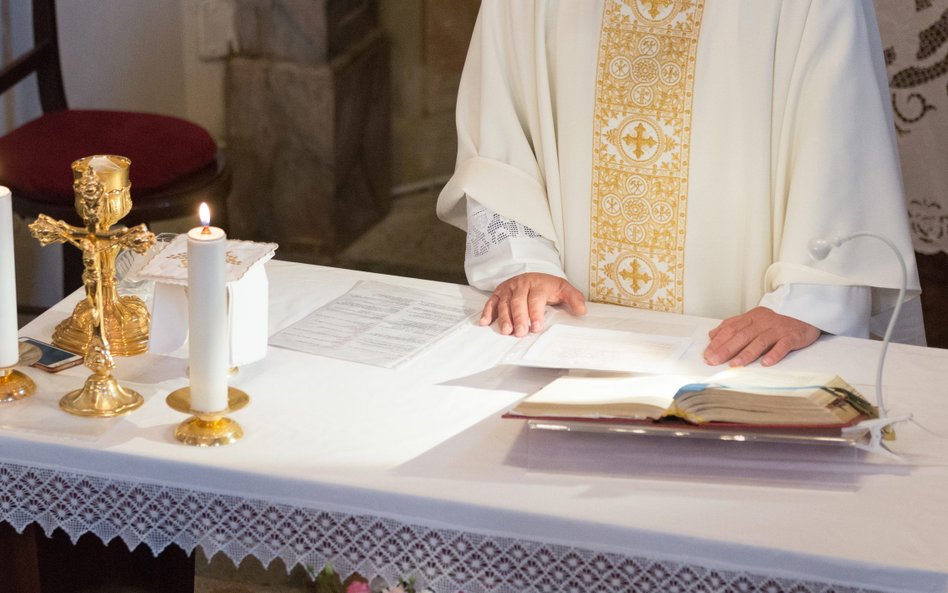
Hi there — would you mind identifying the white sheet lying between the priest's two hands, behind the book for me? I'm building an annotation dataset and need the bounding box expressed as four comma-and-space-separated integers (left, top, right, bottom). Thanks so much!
504, 324, 691, 373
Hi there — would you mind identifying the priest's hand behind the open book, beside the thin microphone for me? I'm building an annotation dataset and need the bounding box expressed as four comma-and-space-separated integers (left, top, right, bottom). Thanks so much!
704, 307, 820, 366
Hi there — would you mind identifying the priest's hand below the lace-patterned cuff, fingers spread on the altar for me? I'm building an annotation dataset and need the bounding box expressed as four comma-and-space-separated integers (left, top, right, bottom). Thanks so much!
479, 272, 586, 337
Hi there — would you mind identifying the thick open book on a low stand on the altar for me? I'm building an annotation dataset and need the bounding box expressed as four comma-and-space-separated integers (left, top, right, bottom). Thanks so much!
505, 368, 876, 428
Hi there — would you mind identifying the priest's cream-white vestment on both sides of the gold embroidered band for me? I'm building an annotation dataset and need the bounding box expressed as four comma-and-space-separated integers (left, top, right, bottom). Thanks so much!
438, 0, 924, 343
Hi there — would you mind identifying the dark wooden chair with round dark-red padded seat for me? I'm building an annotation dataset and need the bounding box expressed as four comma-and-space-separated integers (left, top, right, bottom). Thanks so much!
0, 0, 231, 293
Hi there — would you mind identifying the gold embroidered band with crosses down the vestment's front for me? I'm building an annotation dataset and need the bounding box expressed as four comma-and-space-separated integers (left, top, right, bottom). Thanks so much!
589, 0, 704, 313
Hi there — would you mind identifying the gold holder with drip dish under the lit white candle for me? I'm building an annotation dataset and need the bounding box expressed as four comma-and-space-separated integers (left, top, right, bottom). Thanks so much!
165, 387, 250, 447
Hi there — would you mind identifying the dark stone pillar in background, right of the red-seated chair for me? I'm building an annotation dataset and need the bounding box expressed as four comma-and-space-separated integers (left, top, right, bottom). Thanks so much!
227, 0, 391, 262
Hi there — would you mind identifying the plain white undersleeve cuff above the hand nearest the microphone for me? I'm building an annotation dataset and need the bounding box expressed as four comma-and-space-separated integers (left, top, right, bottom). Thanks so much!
760, 284, 872, 338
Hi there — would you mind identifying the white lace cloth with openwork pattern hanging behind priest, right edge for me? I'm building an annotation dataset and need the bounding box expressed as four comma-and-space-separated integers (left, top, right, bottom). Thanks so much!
875, 0, 948, 254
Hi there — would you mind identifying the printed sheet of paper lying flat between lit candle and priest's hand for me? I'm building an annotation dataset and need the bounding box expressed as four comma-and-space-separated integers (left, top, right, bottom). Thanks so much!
270, 281, 476, 368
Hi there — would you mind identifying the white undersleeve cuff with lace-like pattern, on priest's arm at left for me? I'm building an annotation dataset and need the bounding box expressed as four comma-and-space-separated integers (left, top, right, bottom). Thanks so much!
464, 197, 566, 291
